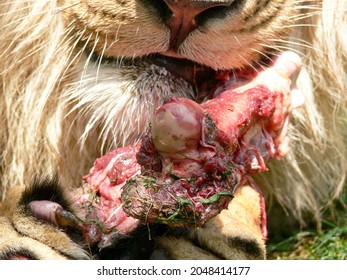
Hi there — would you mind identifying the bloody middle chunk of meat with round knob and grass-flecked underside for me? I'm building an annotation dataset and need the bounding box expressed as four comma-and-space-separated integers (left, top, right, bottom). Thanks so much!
121, 86, 276, 226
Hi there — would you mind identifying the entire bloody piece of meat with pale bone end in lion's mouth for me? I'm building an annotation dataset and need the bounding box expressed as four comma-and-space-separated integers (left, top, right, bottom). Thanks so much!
78, 52, 303, 247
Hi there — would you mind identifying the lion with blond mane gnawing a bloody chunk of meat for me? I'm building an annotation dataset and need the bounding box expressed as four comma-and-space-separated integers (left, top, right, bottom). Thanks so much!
0, 0, 347, 259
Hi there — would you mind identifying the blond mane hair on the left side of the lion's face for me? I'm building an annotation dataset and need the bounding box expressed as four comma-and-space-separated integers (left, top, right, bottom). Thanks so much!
0, 0, 76, 196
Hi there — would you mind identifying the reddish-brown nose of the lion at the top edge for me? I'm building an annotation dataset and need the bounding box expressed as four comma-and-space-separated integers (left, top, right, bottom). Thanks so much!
164, 0, 234, 50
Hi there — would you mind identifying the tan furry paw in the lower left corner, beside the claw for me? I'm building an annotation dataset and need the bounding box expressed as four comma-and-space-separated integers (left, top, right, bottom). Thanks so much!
0, 186, 87, 260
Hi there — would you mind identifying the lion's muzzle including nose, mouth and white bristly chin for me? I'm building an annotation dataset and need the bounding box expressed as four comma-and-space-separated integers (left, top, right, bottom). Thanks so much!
61, 0, 298, 152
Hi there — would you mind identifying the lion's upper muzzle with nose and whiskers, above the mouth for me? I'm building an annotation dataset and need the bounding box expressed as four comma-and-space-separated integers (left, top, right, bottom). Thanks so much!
64, 0, 300, 69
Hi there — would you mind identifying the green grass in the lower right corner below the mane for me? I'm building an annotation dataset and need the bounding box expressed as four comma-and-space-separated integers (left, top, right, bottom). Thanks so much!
267, 195, 347, 260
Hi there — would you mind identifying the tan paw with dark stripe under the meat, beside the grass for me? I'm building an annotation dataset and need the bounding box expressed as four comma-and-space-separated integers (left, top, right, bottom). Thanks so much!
159, 186, 265, 260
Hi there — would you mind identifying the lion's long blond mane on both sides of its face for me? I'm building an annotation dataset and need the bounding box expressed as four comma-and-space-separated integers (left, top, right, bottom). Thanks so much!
0, 0, 347, 228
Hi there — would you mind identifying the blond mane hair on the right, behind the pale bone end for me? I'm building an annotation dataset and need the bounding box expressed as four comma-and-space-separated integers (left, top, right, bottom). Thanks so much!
258, 0, 347, 224
